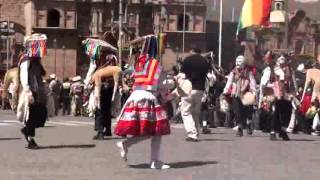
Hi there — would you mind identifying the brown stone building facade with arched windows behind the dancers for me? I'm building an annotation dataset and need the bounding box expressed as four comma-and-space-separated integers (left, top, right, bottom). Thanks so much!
0, 0, 206, 79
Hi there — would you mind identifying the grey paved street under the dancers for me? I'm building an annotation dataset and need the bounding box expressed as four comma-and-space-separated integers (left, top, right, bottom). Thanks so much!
0, 111, 320, 180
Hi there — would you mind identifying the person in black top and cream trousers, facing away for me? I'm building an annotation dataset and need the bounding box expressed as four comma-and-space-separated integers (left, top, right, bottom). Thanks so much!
180, 49, 210, 142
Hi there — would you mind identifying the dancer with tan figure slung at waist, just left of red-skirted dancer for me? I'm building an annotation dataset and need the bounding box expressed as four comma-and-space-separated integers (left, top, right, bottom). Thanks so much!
82, 38, 121, 140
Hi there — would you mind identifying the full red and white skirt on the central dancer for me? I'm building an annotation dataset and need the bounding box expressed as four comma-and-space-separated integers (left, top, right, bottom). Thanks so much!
115, 90, 170, 136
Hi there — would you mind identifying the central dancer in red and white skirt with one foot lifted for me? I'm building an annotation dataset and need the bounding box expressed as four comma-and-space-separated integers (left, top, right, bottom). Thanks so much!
115, 38, 170, 169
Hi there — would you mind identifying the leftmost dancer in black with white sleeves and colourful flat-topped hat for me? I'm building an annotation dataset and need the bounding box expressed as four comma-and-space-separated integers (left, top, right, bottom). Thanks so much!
17, 34, 47, 149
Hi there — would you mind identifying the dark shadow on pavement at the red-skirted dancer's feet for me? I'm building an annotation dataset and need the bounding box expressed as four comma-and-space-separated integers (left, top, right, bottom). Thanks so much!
129, 161, 218, 169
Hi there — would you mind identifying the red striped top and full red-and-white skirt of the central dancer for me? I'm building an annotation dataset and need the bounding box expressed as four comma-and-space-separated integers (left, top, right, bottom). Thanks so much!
115, 55, 170, 136
